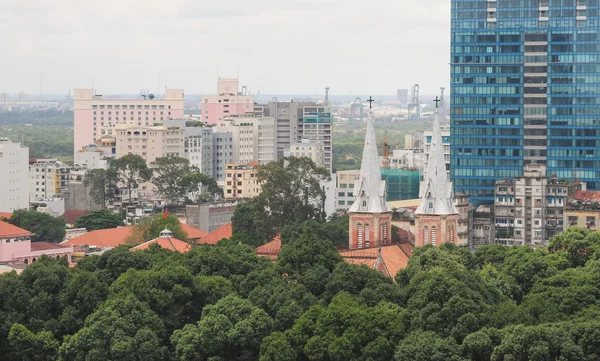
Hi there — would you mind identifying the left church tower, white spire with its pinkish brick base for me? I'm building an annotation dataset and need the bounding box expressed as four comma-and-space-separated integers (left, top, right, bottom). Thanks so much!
348, 98, 392, 249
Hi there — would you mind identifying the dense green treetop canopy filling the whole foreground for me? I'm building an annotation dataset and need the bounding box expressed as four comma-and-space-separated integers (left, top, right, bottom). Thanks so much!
0, 227, 600, 361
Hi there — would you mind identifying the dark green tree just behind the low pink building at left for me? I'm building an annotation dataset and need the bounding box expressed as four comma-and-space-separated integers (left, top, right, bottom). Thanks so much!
8, 209, 66, 243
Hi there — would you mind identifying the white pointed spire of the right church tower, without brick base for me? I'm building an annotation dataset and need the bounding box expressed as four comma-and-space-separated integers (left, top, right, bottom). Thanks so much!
415, 99, 458, 215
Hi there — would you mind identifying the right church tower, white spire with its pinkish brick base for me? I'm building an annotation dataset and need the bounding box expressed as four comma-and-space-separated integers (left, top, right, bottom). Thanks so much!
415, 97, 458, 247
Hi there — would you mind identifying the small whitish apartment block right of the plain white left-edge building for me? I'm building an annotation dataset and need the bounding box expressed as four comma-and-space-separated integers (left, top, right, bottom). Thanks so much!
29, 159, 71, 202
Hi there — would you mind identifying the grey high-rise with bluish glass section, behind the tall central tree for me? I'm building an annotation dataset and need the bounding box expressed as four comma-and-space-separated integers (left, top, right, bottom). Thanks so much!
256, 101, 333, 172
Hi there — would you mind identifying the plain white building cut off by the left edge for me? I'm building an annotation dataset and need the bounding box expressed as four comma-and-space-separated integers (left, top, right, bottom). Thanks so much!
0, 138, 29, 212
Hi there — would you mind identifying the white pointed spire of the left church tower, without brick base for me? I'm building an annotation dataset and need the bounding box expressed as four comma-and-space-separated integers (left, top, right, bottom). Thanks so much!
348, 111, 388, 213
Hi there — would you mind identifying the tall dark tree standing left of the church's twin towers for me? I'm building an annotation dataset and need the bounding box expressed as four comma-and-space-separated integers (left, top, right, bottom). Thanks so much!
241, 157, 329, 240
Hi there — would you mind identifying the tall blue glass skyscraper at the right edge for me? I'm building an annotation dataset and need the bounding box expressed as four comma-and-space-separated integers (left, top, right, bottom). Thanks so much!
450, 0, 600, 205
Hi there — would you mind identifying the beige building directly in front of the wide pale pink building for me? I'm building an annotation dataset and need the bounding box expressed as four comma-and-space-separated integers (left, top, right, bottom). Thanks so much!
115, 126, 185, 166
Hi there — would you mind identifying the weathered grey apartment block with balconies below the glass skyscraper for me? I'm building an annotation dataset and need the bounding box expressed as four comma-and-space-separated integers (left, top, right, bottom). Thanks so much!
494, 164, 585, 246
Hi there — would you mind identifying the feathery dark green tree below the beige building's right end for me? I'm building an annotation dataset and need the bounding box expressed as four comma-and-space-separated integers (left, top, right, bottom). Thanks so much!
150, 155, 192, 204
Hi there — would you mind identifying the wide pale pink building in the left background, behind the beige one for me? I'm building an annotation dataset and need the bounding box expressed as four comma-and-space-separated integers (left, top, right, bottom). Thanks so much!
73, 89, 184, 152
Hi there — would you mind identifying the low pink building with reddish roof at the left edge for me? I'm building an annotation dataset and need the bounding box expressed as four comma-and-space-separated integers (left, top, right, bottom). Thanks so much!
0, 221, 73, 264
